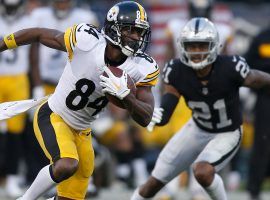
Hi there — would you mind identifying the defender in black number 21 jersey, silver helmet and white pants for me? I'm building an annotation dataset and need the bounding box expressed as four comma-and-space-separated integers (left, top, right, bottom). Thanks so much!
131, 18, 270, 200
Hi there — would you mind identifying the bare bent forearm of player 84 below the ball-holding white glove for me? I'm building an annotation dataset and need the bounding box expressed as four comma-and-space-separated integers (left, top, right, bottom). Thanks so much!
123, 95, 154, 127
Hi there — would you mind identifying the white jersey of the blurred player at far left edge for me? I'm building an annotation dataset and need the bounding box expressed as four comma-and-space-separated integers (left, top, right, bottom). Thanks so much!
0, 15, 34, 76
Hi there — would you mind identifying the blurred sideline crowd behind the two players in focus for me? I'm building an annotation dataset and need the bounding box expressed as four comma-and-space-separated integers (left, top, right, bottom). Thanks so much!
0, 0, 270, 200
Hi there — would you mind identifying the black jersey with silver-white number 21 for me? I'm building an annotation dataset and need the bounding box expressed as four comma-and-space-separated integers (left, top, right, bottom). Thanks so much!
163, 55, 249, 133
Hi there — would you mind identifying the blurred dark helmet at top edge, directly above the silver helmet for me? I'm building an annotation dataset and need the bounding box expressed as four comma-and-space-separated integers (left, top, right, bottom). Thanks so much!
188, 0, 214, 19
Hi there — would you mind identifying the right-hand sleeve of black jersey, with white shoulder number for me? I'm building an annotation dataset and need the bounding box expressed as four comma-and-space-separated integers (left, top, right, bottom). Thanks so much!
230, 56, 250, 86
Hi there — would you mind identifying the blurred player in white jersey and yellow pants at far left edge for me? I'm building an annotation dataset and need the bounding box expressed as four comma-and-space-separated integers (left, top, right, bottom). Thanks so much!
0, 0, 36, 197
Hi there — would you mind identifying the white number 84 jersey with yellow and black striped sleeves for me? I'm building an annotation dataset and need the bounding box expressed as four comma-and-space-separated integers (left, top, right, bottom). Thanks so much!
48, 23, 159, 130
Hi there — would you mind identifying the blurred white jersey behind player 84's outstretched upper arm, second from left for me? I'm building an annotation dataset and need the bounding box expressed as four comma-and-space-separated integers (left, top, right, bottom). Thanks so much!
32, 7, 97, 84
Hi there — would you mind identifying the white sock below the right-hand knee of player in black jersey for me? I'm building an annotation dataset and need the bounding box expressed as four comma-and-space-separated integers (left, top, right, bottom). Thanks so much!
204, 174, 227, 200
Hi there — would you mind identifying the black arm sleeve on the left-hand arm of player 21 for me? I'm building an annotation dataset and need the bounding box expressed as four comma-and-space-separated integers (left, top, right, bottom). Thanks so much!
156, 93, 179, 126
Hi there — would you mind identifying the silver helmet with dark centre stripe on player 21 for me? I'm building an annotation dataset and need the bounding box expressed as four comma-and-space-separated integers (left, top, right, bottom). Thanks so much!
178, 17, 220, 70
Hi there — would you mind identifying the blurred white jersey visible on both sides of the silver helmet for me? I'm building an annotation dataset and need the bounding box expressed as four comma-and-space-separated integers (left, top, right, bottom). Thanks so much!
167, 19, 233, 58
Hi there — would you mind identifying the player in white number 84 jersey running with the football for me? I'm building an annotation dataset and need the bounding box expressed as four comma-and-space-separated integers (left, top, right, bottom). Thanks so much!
0, 1, 159, 200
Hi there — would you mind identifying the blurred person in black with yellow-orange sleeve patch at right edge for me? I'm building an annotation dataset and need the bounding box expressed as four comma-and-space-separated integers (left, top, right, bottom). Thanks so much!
245, 24, 270, 200
